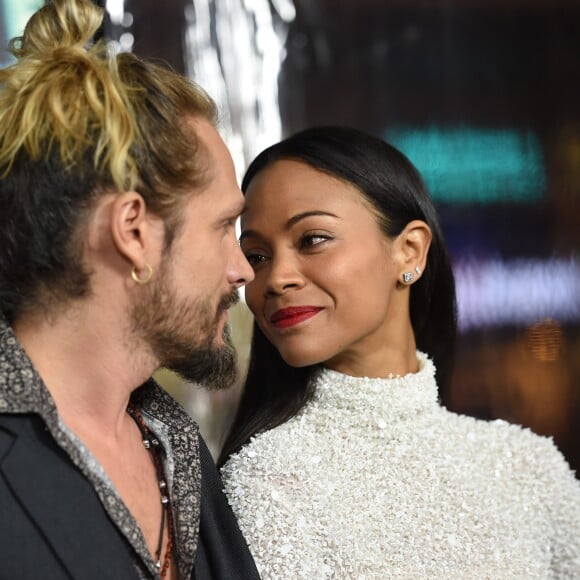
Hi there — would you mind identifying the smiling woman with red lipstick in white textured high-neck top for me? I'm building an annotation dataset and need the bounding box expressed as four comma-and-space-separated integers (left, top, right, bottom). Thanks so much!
220, 127, 580, 580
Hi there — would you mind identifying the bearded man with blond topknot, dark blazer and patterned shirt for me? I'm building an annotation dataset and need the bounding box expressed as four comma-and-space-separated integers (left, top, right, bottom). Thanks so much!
0, 0, 257, 579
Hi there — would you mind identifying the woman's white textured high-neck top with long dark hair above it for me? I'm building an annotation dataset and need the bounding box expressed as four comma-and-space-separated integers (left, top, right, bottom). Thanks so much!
222, 353, 580, 580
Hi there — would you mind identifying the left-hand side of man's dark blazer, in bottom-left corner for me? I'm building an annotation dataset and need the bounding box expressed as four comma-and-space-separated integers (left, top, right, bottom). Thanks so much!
0, 415, 138, 580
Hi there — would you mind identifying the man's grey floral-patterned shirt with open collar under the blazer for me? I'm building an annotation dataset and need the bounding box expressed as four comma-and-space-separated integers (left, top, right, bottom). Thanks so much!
0, 316, 201, 579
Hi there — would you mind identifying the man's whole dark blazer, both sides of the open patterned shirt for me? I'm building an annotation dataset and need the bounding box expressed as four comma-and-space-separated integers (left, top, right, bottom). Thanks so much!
0, 414, 259, 580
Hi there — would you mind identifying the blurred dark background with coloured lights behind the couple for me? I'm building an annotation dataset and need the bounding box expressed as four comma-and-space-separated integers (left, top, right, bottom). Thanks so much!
0, 0, 580, 476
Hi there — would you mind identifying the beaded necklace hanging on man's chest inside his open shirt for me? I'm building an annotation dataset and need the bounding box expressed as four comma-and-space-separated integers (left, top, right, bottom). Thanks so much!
127, 403, 173, 578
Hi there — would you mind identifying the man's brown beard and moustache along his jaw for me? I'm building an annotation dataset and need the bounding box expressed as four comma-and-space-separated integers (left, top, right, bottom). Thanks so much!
131, 271, 239, 390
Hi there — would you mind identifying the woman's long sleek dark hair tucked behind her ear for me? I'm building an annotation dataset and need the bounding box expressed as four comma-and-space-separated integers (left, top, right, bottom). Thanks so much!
219, 127, 456, 465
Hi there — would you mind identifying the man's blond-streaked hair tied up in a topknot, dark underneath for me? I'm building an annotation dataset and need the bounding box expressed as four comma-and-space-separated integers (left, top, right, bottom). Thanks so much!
0, 0, 217, 319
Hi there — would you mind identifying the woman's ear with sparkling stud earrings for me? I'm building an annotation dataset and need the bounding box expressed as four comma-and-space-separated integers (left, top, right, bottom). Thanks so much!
394, 220, 433, 285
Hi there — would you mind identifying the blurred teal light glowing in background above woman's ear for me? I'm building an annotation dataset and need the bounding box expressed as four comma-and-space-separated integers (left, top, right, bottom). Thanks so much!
384, 126, 546, 203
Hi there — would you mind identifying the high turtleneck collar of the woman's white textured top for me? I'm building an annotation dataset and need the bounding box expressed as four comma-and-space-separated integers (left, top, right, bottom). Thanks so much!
312, 351, 438, 418
